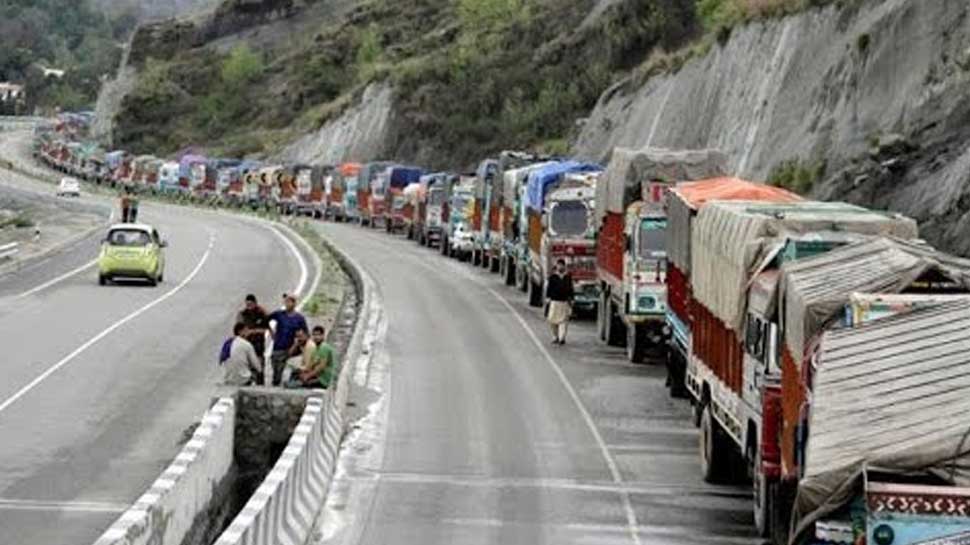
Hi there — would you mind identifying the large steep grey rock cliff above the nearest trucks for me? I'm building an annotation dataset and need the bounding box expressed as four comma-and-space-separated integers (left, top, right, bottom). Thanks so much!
574, 0, 970, 253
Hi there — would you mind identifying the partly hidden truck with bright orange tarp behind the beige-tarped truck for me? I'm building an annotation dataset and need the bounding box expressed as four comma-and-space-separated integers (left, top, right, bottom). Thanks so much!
660, 177, 803, 397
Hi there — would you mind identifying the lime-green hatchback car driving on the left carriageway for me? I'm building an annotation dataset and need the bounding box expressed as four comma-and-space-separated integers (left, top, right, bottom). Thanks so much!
98, 223, 168, 286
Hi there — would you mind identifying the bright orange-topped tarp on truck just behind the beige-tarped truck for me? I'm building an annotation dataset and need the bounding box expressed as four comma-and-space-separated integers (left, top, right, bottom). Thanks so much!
667, 178, 803, 274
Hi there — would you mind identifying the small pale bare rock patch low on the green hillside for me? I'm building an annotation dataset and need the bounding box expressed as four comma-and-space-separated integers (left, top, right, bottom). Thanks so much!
280, 84, 394, 164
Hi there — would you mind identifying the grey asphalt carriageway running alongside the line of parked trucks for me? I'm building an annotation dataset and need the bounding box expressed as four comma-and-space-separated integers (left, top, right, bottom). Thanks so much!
321, 224, 759, 545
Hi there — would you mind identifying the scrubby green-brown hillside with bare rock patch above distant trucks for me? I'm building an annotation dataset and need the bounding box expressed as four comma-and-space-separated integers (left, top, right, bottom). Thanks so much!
96, 0, 700, 166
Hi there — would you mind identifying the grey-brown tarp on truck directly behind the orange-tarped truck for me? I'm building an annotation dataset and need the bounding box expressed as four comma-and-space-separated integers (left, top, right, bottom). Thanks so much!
596, 147, 727, 225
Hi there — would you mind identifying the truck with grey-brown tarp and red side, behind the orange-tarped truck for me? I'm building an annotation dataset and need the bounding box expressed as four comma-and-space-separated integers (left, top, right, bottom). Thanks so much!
596, 147, 727, 363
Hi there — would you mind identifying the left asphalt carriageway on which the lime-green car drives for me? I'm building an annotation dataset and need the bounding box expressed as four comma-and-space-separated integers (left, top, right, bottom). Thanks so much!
0, 152, 314, 545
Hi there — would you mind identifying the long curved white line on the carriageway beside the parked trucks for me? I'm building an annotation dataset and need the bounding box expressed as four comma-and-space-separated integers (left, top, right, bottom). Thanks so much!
352, 230, 641, 545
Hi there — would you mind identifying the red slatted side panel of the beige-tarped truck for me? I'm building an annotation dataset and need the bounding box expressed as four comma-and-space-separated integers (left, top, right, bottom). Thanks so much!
691, 300, 744, 396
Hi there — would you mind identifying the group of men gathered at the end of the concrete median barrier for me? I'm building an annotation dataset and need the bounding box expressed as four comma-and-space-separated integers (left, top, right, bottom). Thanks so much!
219, 294, 339, 388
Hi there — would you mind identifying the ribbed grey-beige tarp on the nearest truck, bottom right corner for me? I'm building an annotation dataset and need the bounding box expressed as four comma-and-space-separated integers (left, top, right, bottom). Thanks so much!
792, 300, 970, 537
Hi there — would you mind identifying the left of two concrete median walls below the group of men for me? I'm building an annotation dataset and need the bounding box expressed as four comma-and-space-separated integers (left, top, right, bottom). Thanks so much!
95, 397, 236, 545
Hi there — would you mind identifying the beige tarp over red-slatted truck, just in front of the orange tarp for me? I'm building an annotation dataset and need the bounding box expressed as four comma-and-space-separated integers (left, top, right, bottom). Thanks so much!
690, 201, 917, 334
